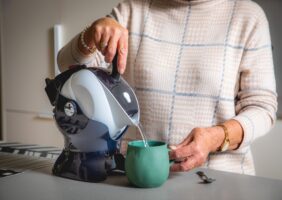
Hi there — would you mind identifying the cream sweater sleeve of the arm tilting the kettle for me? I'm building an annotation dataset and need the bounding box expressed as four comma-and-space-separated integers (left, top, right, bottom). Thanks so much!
57, 1, 132, 71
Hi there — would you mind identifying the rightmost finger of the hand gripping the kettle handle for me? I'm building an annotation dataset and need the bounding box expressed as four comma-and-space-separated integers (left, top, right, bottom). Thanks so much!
118, 31, 128, 74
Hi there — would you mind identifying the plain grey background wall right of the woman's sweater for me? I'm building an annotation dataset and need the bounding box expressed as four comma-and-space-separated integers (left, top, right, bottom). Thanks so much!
252, 0, 282, 179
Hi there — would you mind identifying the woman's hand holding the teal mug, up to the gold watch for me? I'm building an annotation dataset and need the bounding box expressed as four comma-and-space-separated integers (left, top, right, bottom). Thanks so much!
169, 126, 224, 171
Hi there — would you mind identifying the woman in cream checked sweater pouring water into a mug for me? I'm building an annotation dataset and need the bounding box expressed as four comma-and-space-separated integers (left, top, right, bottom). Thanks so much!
58, 0, 277, 174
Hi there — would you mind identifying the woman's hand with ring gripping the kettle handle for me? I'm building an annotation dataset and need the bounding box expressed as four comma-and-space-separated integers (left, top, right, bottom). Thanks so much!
79, 17, 128, 74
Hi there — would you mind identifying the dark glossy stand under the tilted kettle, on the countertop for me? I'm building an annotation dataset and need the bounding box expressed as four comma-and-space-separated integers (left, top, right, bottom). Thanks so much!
52, 150, 124, 182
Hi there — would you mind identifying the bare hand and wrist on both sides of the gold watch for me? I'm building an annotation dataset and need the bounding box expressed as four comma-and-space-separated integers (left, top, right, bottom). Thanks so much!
169, 119, 244, 171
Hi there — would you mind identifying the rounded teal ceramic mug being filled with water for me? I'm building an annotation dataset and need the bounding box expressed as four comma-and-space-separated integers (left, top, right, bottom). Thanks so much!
125, 140, 170, 188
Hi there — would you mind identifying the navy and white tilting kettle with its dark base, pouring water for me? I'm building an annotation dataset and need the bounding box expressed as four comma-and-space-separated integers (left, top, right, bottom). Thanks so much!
45, 57, 140, 182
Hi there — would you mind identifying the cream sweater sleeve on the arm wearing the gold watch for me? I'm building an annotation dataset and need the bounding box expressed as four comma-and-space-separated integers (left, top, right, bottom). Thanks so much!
233, 10, 277, 149
